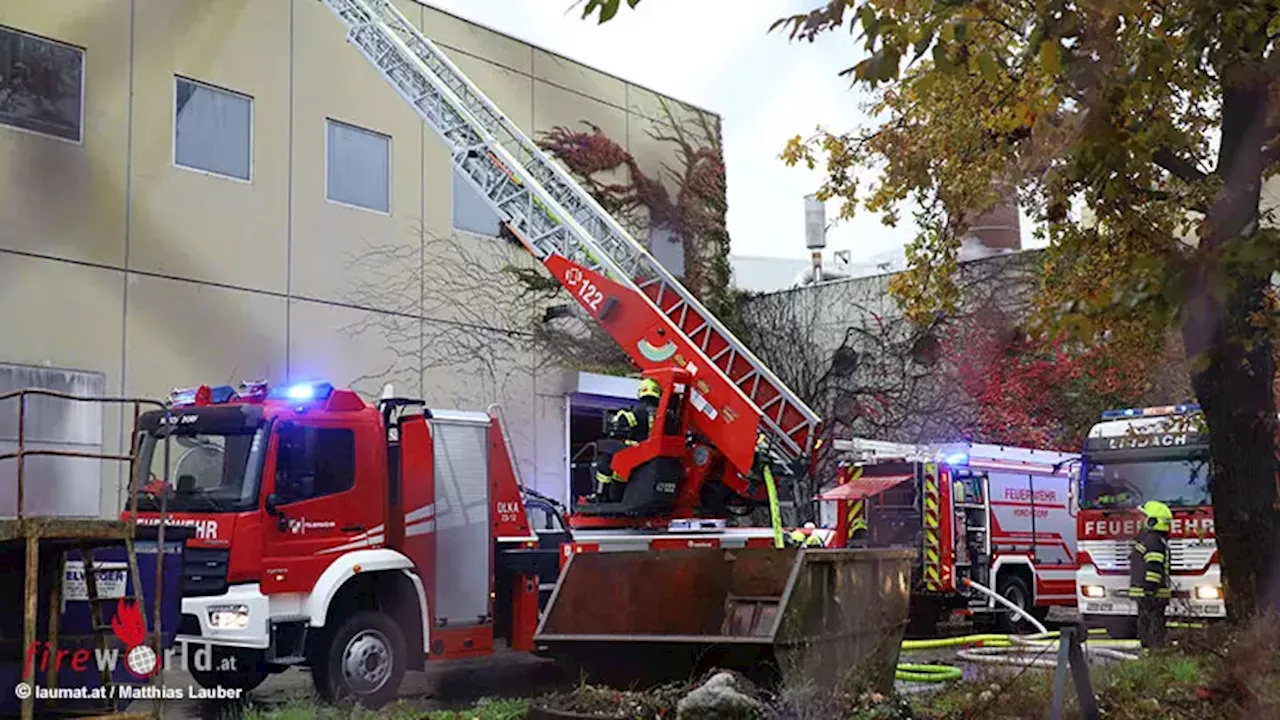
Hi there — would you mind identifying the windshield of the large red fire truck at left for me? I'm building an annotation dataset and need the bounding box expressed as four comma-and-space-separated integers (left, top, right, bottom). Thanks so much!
138, 428, 266, 512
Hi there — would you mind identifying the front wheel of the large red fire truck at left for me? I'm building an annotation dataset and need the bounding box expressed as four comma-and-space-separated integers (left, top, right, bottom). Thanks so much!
311, 611, 408, 710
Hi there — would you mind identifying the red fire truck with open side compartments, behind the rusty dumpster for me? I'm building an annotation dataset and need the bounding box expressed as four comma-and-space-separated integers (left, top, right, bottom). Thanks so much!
818, 439, 1078, 632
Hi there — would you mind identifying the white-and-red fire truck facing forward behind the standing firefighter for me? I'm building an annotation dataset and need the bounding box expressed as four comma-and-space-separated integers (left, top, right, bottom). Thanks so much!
1078, 404, 1226, 635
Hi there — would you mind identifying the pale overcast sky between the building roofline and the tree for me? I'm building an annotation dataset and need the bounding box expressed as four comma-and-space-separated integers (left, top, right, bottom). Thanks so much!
426, 0, 942, 260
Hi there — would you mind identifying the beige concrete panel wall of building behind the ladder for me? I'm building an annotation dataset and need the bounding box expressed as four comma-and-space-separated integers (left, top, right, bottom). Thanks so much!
0, 0, 718, 510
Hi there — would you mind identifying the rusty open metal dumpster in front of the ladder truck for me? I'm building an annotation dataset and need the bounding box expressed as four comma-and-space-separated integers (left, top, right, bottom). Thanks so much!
534, 548, 916, 691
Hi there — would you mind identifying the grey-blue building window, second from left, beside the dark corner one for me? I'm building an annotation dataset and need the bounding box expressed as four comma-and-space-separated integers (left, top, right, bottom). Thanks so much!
173, 78, 253, 181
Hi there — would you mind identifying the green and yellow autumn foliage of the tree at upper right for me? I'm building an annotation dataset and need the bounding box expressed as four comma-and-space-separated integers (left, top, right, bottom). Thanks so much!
774, 0, 1280, 334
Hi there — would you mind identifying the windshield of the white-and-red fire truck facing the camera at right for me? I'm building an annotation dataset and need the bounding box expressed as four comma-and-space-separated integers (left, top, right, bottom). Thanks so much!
1079, 454, 1211, 510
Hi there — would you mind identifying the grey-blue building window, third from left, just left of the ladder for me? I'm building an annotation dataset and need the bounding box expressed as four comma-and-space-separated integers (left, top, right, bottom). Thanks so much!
325, 120, 392, 213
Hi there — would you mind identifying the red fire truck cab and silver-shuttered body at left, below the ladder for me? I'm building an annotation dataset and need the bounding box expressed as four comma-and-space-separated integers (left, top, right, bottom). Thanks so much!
128, 382, 545, 706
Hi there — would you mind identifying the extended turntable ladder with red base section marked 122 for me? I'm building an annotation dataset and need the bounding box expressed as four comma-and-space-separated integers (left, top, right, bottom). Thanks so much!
321, 0, 820, 474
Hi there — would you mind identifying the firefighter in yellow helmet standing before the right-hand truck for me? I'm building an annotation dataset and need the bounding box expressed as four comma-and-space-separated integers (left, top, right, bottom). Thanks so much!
1129, 500, 1174, 648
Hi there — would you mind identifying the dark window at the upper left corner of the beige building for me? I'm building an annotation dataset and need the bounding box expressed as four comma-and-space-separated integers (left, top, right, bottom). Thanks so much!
0, 26, 84, 142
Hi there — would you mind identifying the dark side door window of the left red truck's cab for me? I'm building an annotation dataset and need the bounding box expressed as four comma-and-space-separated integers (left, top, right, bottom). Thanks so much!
275, 427, 356, 502
